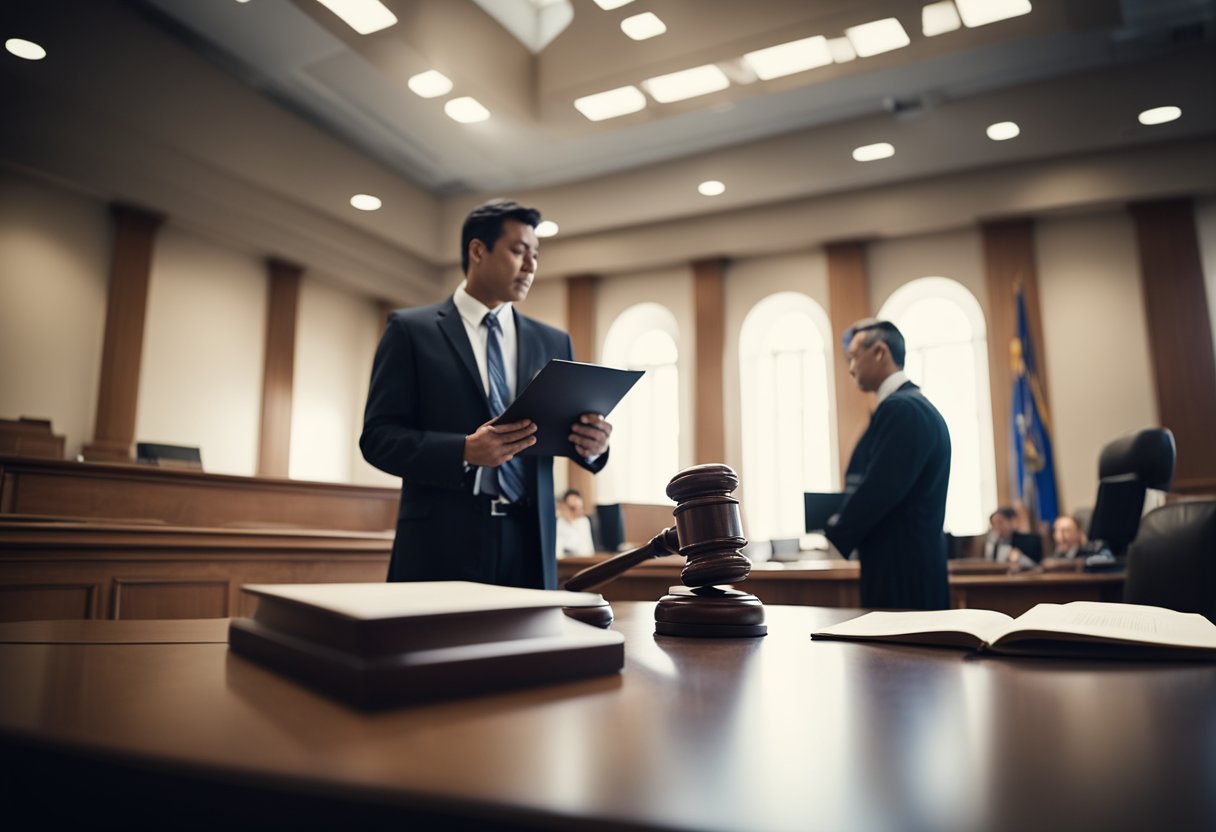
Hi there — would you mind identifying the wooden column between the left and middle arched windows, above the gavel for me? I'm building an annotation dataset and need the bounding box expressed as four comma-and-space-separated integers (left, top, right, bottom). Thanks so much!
692, 258, 726, 465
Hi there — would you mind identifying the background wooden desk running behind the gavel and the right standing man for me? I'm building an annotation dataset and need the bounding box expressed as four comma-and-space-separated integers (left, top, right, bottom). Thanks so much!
557, 555, 1124, 615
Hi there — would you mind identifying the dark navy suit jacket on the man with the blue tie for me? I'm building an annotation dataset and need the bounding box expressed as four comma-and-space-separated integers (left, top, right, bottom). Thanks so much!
359, 298, 608, 589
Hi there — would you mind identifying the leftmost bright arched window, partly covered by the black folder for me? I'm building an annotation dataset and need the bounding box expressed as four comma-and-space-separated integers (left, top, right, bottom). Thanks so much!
598, 303, 680, 504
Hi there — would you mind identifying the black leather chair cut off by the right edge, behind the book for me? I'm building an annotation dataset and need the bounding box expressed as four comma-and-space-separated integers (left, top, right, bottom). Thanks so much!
1124, 500, 1216, 623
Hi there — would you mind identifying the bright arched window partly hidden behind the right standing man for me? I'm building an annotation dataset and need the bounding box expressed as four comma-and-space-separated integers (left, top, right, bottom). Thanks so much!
878, 277, 997, 535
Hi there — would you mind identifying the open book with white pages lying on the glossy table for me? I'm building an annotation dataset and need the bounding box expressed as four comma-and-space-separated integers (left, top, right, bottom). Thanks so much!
811, 601, 1216, 662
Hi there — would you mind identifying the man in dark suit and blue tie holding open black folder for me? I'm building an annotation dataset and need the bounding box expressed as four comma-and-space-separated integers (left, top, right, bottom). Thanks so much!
359, 199, 612, 589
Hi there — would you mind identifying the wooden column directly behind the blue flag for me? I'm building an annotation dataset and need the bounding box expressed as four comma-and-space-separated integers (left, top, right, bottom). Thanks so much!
980, 219, 1051, 505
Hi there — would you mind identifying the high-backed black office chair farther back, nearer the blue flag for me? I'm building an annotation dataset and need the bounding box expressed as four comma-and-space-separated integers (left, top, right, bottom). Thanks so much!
1086, 428, 1177, 559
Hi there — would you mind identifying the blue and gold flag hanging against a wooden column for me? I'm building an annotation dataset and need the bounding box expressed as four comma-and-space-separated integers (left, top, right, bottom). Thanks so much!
1009, 286, 1059, 523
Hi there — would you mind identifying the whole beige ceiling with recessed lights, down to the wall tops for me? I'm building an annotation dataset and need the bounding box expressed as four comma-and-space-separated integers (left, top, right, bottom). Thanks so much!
0, 0, 1216, 300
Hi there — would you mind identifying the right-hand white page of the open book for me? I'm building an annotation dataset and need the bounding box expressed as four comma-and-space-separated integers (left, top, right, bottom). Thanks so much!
990, 601, 1216, 650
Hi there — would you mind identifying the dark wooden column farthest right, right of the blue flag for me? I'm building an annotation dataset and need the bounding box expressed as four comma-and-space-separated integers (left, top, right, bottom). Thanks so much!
1128, 198, 1216, 494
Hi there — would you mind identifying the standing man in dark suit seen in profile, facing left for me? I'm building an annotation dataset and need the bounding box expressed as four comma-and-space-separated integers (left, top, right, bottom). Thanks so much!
824, 319, 950, 609
